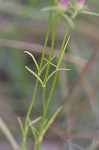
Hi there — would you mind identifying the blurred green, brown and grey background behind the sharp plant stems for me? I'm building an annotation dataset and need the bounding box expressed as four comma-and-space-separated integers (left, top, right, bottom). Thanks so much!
0, 0, 99, 150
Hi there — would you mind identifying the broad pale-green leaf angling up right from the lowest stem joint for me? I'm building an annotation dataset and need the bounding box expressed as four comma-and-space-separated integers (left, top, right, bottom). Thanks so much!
43, 106, 63, 134
